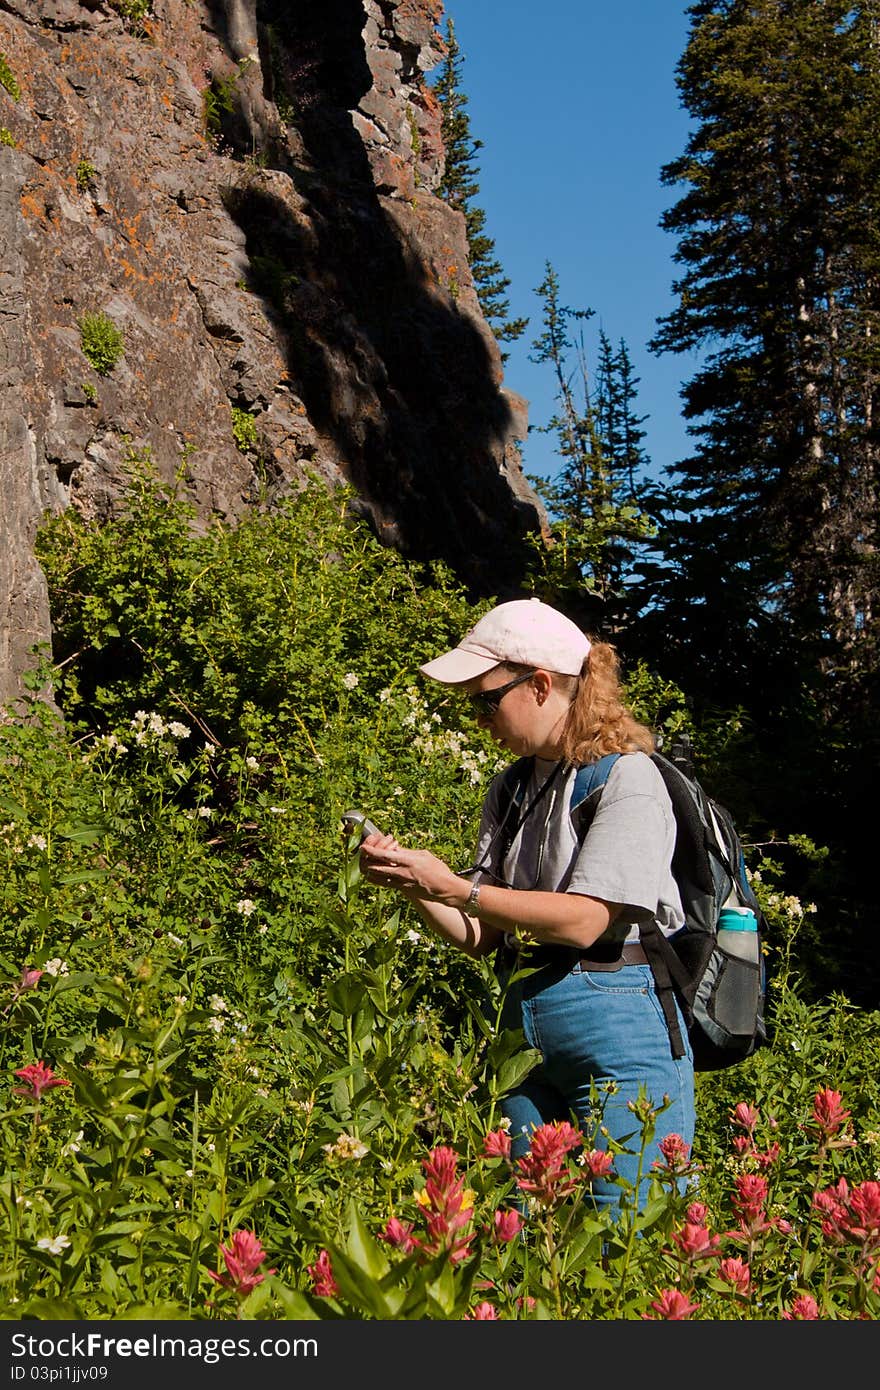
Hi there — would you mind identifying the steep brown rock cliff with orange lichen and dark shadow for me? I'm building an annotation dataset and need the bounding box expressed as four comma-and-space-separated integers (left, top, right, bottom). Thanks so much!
0, 0, 544, 698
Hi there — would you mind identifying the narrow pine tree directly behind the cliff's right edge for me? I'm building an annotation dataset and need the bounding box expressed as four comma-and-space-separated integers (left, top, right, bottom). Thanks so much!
434, 19, 528, 359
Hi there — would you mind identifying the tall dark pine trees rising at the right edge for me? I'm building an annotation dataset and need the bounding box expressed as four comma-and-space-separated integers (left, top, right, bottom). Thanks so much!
653, 0, 880, 705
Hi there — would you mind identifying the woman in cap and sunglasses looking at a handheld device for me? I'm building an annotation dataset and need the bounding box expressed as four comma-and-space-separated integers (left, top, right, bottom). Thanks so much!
361, 599, 694, 1208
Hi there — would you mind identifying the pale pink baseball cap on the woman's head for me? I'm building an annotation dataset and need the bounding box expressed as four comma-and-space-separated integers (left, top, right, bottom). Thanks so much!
418, 599, 589, 685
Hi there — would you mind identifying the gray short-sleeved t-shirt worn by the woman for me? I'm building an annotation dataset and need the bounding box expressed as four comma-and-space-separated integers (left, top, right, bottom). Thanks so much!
474, 753, 684, 941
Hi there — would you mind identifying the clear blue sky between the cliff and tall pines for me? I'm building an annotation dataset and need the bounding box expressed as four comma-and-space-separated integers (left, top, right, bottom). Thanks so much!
446, 0, 695, 477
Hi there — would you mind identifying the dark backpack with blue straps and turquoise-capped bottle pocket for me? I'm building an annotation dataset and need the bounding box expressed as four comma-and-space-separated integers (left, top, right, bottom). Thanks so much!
502, 745, 767, 1072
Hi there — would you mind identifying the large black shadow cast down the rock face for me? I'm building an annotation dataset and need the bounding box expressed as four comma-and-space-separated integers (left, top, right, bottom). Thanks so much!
208, 0, 537, 594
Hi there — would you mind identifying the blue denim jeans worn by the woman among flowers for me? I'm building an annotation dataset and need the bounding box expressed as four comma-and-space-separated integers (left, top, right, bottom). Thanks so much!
502, 963, 694, 1211
